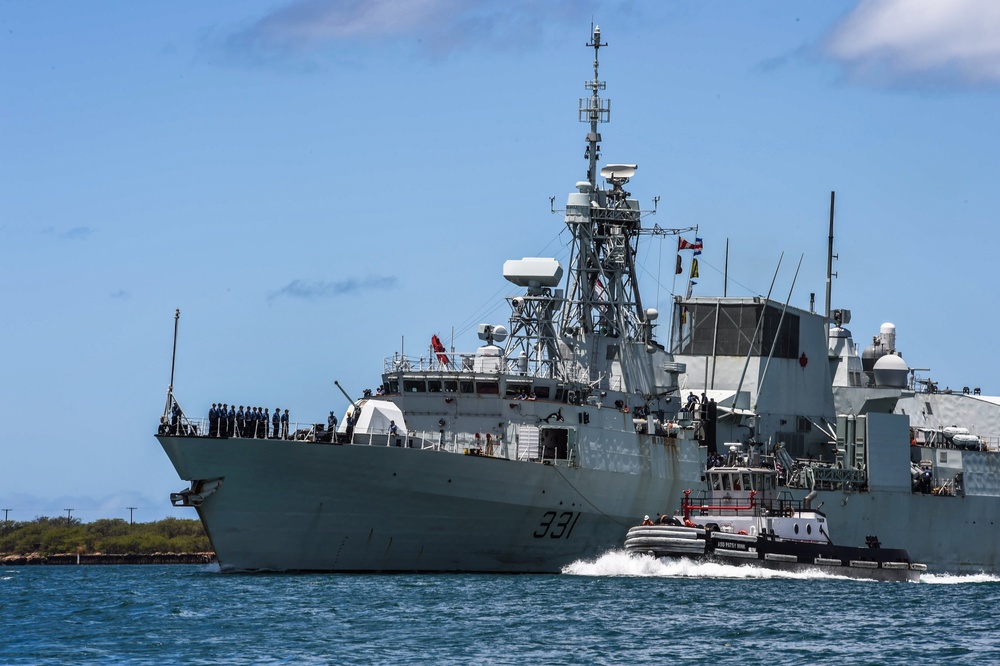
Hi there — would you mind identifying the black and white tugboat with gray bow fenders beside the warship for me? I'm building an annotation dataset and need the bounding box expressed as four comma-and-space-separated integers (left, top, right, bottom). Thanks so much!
625, 444, 927, 581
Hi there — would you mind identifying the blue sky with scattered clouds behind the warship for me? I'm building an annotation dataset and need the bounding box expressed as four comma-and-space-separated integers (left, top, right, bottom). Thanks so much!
0, 0, 1000, 520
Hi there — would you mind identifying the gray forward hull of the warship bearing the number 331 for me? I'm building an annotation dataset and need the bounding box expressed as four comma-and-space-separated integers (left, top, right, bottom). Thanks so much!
157, 436, 698, 572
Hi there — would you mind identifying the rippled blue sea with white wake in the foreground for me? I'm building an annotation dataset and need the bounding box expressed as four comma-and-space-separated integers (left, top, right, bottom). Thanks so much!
0, 552, 1000, 666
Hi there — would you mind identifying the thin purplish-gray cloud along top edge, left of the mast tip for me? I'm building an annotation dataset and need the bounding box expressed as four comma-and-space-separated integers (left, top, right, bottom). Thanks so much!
227, 0, 596, 61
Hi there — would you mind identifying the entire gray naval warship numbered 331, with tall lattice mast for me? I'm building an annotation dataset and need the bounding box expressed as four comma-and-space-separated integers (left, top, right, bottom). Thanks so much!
157, 29, 1000, 573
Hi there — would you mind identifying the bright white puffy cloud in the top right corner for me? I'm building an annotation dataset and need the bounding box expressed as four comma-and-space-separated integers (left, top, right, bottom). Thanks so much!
826, 0, 1000, 87
